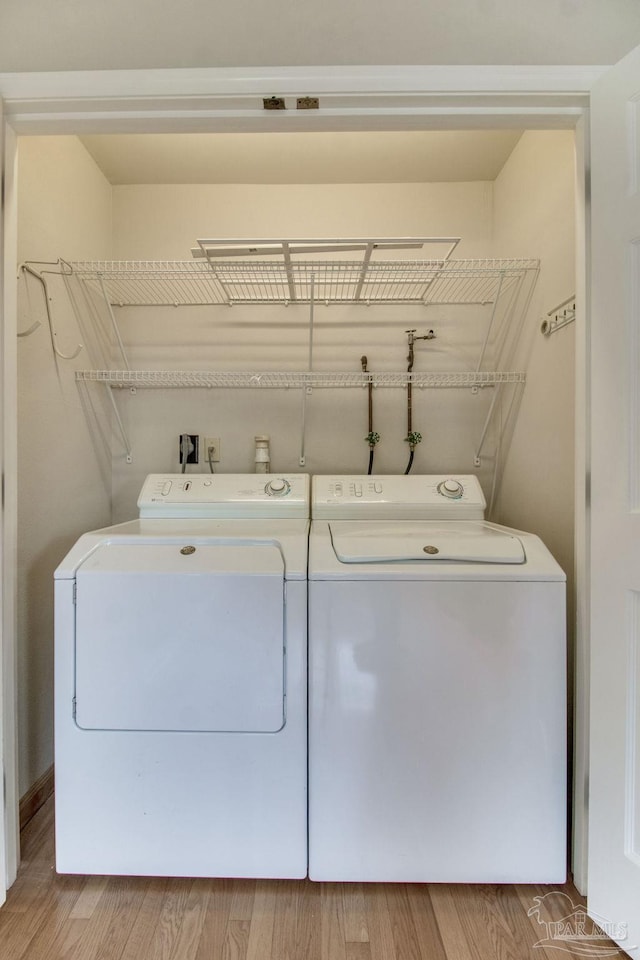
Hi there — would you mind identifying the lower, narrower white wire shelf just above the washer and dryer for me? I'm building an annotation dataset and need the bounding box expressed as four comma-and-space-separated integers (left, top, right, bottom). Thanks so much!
76, 370, 526, 389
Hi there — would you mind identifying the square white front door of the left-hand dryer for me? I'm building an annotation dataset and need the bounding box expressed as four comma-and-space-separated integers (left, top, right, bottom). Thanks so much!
74, 540, 285, 732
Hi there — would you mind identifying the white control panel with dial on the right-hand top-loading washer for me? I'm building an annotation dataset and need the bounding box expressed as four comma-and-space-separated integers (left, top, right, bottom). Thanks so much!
311, 474, 486, 520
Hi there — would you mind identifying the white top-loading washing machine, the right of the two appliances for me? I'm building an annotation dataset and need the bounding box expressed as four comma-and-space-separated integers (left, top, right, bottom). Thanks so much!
309, 475, 567, 883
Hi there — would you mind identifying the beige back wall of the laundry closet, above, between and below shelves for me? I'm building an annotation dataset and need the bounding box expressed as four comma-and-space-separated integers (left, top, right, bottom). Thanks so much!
114, 182, 492, 519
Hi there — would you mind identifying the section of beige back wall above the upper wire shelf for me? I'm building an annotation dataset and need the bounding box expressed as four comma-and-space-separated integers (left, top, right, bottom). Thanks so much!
113, 182, 492, 260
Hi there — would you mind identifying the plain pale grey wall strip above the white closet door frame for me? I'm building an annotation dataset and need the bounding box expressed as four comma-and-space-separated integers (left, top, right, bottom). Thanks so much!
0, 0, 640, 71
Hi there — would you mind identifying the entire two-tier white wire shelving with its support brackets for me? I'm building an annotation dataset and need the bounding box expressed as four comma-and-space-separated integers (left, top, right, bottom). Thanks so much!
22, 237, 539, 465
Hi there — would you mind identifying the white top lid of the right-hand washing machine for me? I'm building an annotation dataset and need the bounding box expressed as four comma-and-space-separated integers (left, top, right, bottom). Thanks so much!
329, 521, 526, 563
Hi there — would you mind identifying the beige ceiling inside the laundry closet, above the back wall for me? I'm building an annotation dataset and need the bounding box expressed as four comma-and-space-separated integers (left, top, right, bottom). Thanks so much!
81, 130, 521, 185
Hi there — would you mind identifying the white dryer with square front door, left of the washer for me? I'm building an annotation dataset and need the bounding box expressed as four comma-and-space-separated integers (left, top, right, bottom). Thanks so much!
55, 474, 309, 878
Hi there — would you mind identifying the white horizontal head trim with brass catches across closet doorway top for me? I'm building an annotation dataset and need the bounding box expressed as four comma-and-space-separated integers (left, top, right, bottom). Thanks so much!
0, 66, 606, 134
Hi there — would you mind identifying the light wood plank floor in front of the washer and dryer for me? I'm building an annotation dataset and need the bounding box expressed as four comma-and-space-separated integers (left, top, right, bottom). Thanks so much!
0, 800, 623, 960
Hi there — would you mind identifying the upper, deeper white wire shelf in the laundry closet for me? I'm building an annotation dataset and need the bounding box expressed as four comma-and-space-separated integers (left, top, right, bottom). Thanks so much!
68, 259, 539, 306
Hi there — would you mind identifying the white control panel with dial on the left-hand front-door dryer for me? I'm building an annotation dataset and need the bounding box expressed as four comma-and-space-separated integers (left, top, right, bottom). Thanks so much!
138, 473, 309, 520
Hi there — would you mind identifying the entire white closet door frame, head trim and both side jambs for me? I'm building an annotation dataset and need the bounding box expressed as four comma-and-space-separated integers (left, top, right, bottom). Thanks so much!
0, 65, 596, 892
